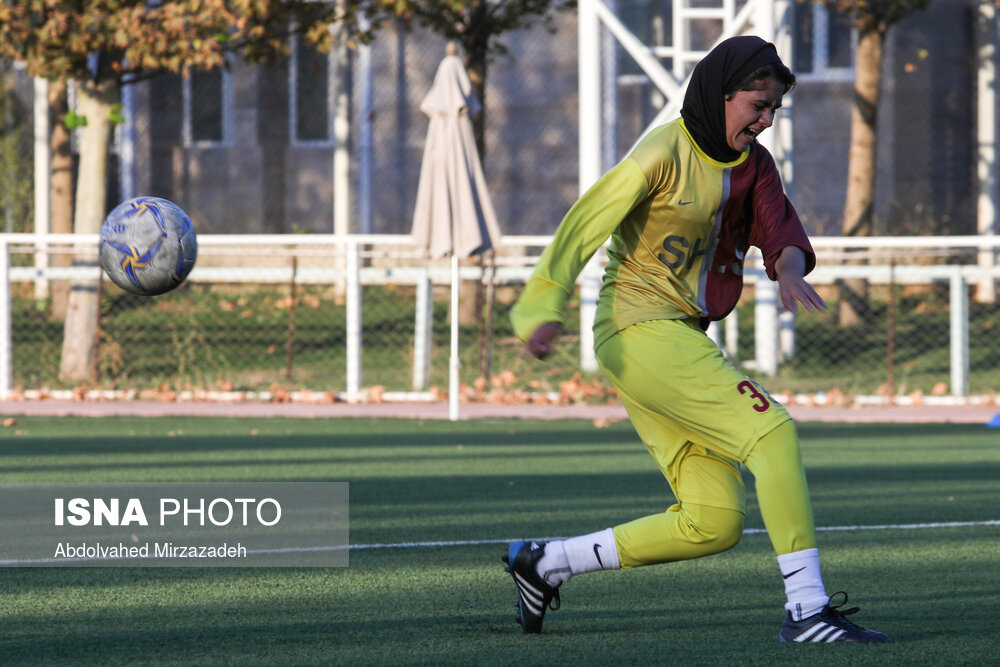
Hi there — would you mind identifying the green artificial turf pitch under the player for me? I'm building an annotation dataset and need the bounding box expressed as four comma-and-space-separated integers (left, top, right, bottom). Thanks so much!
0, 417, 1000, 665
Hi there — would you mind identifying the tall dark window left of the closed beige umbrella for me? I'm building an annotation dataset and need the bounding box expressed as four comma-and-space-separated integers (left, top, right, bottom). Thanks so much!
289, 28, 333, 144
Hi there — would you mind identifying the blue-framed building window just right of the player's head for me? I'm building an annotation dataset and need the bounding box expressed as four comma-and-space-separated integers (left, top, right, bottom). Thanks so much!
793, 3, 855, 81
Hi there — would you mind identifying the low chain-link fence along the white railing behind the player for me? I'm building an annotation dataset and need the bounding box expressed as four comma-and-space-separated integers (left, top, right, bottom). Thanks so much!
1, 237, 1000, 403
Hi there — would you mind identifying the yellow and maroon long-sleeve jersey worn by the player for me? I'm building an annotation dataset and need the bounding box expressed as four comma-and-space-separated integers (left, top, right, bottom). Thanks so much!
511, 119, 815, 346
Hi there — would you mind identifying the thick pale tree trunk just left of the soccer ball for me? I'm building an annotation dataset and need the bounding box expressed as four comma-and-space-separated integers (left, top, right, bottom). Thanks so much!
59, 80, 120, 382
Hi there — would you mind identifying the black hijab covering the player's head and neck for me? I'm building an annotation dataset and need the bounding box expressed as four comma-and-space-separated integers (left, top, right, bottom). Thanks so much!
681, 35, 781, 162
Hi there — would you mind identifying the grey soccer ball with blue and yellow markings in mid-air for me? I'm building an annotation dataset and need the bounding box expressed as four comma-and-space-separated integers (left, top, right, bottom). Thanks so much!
99, 197, 198, 296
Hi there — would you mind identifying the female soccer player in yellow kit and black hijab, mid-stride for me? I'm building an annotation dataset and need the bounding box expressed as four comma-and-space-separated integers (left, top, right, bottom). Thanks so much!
504, 36, 892, 642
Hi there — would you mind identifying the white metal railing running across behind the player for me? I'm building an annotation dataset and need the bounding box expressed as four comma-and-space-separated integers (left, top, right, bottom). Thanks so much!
0, 234, 1000, 400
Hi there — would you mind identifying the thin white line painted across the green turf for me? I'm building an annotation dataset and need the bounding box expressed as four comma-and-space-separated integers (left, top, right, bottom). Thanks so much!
0, 519, 1000, 567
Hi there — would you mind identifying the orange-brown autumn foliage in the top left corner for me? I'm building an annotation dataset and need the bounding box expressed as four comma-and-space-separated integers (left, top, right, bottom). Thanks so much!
0, 0, 336, 82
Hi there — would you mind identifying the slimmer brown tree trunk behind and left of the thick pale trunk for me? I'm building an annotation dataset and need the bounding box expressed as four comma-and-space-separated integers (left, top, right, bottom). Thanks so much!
48, 79, 73, 320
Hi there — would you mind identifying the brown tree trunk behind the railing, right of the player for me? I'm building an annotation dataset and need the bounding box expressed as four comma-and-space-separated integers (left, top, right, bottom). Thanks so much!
839, 30, 885, 324
